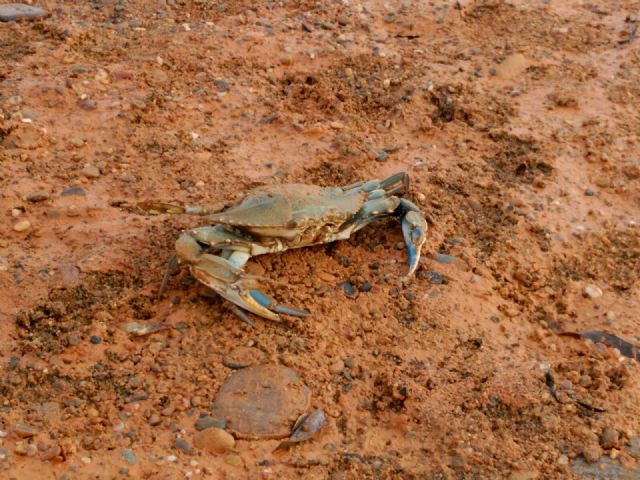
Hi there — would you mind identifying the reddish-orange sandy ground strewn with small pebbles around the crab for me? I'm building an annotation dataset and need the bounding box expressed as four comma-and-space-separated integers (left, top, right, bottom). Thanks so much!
0, 0, 640, 480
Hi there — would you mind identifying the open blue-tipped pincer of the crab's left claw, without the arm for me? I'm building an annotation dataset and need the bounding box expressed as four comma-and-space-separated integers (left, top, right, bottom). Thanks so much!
191, 254, 307, 325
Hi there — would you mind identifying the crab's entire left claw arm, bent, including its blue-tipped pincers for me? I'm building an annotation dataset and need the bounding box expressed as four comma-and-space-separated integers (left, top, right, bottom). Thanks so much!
176, 227, 307, 325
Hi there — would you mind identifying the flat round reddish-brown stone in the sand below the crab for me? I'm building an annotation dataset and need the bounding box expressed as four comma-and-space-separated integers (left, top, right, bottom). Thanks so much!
212, 365, 311, 440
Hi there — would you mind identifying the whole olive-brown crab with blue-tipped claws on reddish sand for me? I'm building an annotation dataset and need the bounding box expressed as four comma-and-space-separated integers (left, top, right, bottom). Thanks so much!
139, 173, 427, 325
